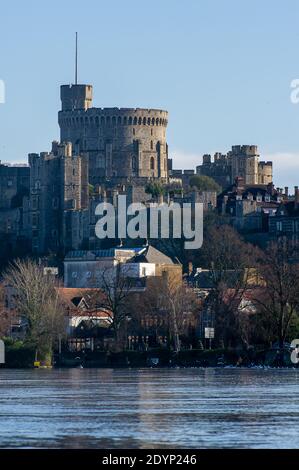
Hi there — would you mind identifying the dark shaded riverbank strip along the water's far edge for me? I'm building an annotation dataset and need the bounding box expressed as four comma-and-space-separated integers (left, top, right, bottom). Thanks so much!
4, 345, 294, 368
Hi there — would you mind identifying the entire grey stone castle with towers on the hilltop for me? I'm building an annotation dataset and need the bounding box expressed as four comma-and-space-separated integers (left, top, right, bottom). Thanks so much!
0, 80, 272, 255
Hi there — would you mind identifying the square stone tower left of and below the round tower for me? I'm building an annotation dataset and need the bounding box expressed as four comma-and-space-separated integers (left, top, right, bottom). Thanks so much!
29, 142, 88, 253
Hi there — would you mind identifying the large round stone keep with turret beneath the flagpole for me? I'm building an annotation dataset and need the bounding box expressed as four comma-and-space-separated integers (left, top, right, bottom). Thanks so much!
58, 85, 168, 184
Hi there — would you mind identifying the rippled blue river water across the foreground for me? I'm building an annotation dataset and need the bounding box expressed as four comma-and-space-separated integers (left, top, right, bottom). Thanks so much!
0, 369, 299, 448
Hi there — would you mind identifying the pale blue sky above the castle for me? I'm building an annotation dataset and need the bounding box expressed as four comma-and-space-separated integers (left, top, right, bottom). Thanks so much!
0, 0, 299, 186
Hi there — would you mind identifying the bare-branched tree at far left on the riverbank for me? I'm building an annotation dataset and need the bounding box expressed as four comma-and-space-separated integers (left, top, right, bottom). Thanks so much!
4, 259, 65, 359
